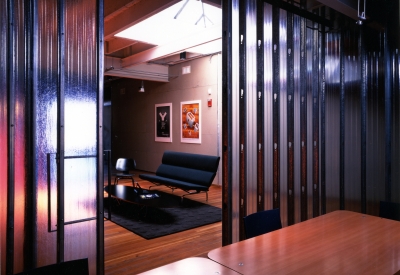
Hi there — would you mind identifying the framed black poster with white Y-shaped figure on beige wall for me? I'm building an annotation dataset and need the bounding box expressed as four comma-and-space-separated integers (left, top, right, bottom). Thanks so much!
155, 103, 172, 142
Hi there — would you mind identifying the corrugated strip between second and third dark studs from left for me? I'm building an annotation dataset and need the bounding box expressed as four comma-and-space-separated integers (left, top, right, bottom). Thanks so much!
33, 0, 58, 266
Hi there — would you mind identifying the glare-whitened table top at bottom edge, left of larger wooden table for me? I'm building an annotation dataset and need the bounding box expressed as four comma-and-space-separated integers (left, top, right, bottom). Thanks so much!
139, 257, 238, 275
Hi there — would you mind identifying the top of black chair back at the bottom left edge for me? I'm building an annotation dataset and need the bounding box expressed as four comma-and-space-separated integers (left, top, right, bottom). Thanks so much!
17, 258, 89, 275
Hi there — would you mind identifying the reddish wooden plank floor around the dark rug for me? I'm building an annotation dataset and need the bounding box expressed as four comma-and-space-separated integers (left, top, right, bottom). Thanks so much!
104, 172, 222, 275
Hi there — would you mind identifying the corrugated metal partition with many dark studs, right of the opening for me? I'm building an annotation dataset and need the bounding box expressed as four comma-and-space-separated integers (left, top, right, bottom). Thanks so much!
223, 0, 400, 244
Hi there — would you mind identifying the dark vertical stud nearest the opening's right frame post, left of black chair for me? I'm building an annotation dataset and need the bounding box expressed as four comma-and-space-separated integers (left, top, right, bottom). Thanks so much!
238, 1, 248, 242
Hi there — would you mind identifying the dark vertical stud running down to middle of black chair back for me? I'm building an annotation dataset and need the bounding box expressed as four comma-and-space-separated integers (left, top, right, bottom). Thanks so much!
257, 1, 265, 211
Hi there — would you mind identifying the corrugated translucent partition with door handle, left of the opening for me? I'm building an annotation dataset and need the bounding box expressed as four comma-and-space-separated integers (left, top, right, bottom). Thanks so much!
0, 0, 104, 274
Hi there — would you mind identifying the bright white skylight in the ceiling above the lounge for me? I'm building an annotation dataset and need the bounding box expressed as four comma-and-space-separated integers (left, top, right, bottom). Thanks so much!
115, 0, 222, 45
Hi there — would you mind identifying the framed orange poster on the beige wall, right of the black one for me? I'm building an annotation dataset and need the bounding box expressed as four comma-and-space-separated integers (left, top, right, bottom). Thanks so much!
181, 100, 202, 143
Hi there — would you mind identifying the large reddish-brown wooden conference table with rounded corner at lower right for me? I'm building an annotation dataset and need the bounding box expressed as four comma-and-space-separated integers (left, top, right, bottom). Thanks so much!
208, 211, 400, 275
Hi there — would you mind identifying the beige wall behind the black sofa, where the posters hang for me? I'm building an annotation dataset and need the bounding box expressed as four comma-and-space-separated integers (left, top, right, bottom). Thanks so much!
106, 55, 221, 184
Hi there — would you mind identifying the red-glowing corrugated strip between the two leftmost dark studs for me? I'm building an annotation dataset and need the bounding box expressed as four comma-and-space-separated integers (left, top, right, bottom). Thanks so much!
12, 2, 31, 272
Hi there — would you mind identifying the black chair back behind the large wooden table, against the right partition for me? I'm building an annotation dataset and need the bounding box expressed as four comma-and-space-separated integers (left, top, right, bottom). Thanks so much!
243, 208, 282, 239
